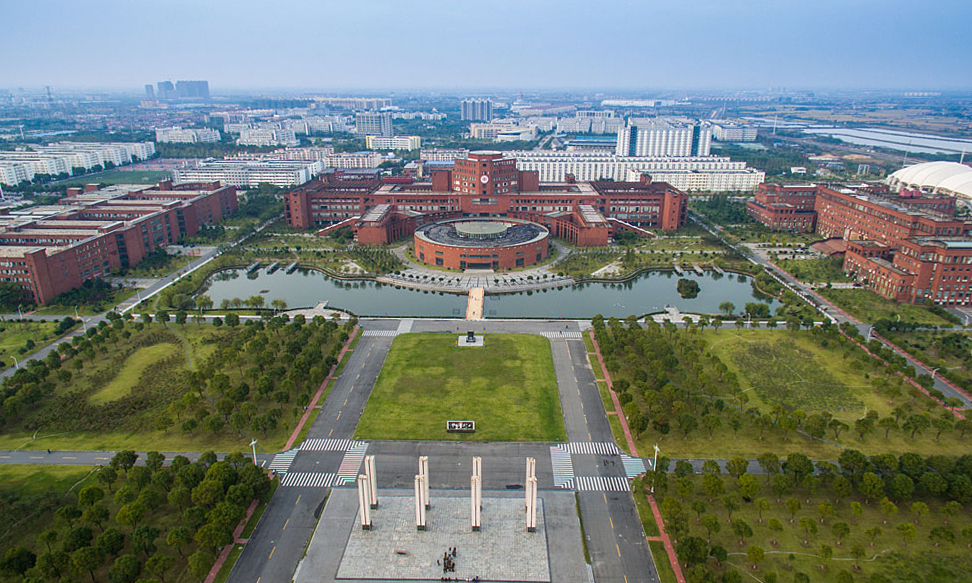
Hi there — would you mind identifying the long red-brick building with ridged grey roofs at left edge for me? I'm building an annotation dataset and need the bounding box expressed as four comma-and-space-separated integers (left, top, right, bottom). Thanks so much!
0, 182, 237, 304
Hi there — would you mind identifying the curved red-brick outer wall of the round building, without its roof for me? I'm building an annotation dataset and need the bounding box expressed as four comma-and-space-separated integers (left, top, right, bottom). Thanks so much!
414, 219, 550, 270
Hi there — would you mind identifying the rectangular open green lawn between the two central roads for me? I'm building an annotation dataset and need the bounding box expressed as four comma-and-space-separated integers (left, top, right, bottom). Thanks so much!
356, 334, 565, 441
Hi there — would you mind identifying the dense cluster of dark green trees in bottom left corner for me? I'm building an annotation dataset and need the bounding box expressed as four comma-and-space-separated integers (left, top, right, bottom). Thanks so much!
0, 451, 270, 583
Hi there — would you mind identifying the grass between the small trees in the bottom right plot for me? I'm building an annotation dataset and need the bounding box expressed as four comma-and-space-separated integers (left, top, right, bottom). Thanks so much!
648, 474, 972, 583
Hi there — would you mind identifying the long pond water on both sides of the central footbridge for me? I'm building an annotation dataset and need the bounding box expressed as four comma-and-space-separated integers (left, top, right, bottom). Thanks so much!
199, 269, 779, 318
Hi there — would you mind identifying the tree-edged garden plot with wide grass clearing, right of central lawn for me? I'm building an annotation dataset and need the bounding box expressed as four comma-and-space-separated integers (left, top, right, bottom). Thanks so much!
594, 318, 972, 459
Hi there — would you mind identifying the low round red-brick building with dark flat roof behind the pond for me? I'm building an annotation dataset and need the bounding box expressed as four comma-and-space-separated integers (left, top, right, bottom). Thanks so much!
415, 219, 550, 270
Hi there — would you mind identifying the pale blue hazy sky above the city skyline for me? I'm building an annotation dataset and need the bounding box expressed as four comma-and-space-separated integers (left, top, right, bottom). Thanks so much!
0, 0, 972, 93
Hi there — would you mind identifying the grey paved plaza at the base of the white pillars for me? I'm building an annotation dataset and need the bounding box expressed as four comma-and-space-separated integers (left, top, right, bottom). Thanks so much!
295, 488, 588, 583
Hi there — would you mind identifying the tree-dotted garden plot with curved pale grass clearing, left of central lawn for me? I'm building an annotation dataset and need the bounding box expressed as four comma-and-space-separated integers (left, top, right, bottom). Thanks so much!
0, 312, 353, 451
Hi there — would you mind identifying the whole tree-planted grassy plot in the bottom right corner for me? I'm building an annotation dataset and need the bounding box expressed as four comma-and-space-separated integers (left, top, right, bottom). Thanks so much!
635, 452, 972, 583
